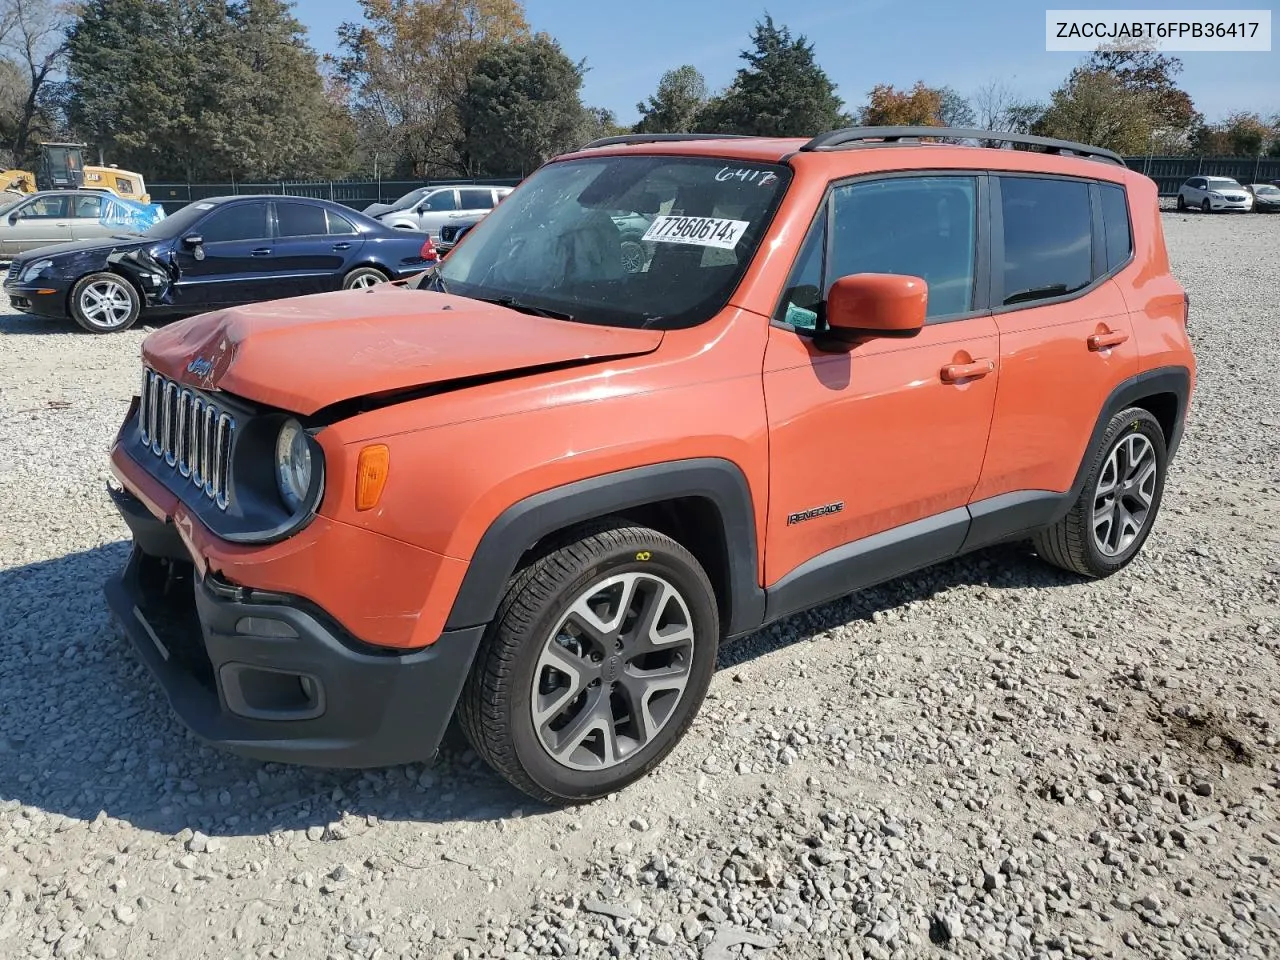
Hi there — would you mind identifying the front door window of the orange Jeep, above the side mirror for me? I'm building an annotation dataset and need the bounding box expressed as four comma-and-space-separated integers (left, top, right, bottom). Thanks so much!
823, 177, 977, 319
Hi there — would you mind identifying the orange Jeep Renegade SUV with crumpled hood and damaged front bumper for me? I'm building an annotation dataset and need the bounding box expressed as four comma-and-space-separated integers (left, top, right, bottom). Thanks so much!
106, 127, 1196, 803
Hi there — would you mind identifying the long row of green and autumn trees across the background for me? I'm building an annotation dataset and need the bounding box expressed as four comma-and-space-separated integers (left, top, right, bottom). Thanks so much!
0, 0, 1280, 182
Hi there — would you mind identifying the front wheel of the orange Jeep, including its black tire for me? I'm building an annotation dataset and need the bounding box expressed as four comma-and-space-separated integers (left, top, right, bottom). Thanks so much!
458, 521, 719, 805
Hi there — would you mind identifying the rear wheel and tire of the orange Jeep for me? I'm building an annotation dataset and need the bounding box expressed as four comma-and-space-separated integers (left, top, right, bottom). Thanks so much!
1034, 407, 1169, 577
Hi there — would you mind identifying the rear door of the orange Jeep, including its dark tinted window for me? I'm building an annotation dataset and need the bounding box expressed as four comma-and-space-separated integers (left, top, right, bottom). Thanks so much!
974, 174, 1138, 529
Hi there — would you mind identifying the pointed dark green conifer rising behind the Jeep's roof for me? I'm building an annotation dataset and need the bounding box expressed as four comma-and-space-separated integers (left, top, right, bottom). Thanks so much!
698, 15, 849, 137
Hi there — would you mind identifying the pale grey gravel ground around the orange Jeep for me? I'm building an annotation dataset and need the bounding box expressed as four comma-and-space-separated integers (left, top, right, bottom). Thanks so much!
0, 214, 1280, 960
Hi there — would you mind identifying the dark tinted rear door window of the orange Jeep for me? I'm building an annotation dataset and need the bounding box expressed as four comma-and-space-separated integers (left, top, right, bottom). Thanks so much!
998, 177, 1093, 306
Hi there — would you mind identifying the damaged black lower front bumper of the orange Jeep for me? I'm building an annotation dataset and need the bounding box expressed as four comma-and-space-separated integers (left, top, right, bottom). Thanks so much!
105, 492, 484, 768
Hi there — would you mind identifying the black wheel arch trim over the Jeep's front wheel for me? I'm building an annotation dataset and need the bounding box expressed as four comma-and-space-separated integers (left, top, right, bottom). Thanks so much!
444, 457, 764, 636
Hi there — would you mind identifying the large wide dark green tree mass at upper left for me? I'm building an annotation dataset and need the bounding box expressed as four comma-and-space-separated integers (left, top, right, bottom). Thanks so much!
65, 0, 349, 179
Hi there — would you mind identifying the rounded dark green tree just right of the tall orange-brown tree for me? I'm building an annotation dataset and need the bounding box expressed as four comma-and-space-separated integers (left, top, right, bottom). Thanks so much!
458, 33, 585, 177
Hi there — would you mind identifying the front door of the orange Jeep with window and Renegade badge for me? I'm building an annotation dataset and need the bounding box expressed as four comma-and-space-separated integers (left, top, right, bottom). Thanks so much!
764, 174, 1000, 593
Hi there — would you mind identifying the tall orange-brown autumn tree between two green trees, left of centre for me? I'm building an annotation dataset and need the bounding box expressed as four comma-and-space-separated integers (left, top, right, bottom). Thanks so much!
334, 0, 530, 177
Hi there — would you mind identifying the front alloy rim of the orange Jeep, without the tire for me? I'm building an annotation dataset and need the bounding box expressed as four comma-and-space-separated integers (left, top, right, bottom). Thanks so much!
530, 572, 696, 771
